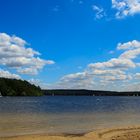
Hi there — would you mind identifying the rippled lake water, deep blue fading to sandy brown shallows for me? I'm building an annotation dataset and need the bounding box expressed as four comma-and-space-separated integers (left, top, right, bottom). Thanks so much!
0, 96, 140, 136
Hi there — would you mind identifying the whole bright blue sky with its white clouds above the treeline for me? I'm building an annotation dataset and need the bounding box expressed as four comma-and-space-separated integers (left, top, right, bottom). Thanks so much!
0, 0, 140, 90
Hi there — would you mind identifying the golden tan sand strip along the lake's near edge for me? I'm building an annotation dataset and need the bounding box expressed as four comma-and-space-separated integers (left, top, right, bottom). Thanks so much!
0, 126, 140, 140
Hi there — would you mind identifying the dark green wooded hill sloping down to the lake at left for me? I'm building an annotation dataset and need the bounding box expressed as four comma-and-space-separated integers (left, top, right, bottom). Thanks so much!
0, 78, 43, 96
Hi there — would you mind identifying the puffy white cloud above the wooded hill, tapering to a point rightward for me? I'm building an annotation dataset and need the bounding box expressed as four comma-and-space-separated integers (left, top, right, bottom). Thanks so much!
0, 33, 54, 75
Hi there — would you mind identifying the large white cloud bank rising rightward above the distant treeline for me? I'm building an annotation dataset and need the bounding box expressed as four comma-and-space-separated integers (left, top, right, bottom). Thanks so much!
46, 40, 140, 90
